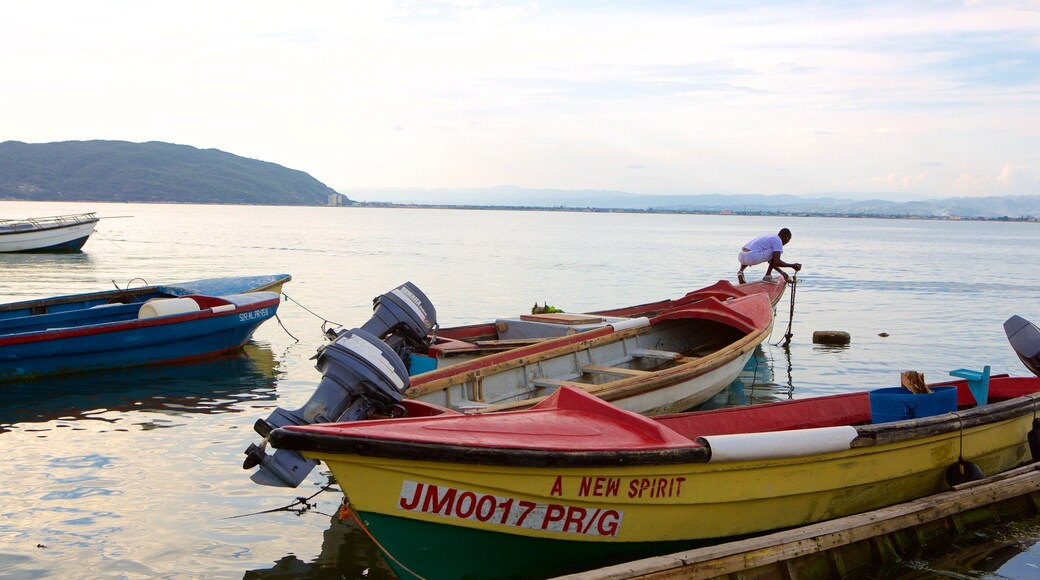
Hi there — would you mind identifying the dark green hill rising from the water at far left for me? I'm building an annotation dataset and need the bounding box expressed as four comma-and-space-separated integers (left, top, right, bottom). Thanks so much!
0, 140, 347, 206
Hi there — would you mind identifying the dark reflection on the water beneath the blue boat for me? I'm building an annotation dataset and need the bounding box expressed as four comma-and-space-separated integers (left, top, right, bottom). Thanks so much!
0, 342, 280, 432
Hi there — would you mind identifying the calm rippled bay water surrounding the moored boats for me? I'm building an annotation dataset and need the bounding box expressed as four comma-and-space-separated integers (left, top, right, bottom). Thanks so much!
0, 202, 1040, 578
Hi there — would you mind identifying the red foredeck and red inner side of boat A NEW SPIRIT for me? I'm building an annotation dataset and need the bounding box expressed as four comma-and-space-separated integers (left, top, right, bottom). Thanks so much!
270, 376, 1040, 468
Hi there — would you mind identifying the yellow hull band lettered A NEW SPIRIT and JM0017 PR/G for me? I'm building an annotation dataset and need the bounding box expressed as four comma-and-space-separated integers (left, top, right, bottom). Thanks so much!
305, 417, 1032, 543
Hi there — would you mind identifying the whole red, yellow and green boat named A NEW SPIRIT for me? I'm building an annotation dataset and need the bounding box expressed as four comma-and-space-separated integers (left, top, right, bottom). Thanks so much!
269, 373, 1040, 578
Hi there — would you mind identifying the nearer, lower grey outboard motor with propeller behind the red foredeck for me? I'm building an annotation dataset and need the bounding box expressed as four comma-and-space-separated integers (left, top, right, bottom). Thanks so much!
242, 328, 409, 487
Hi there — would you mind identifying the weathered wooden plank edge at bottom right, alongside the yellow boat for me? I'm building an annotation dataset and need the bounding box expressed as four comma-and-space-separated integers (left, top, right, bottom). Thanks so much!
562, 464, 1040, 580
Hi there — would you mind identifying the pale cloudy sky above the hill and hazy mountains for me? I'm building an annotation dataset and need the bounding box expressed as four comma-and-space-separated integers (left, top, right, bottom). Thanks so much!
0, 0, 1040, 201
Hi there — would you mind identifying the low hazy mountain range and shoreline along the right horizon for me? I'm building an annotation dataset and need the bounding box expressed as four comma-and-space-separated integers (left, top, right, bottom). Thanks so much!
347, 186, 1040, 219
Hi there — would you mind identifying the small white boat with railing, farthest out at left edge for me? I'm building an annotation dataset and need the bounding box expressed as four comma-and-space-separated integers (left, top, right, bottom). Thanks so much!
0, 212, 101, 253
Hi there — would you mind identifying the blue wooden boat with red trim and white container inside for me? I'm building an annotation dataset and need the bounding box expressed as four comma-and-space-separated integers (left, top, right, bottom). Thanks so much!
0, 274, 291, 380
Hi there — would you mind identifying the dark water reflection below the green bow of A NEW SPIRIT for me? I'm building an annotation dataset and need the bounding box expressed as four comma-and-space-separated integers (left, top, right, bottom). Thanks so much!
242, 516, 396, 580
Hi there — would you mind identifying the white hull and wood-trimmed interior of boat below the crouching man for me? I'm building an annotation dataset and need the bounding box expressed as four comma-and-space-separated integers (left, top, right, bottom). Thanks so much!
407, 305, 772, 415
